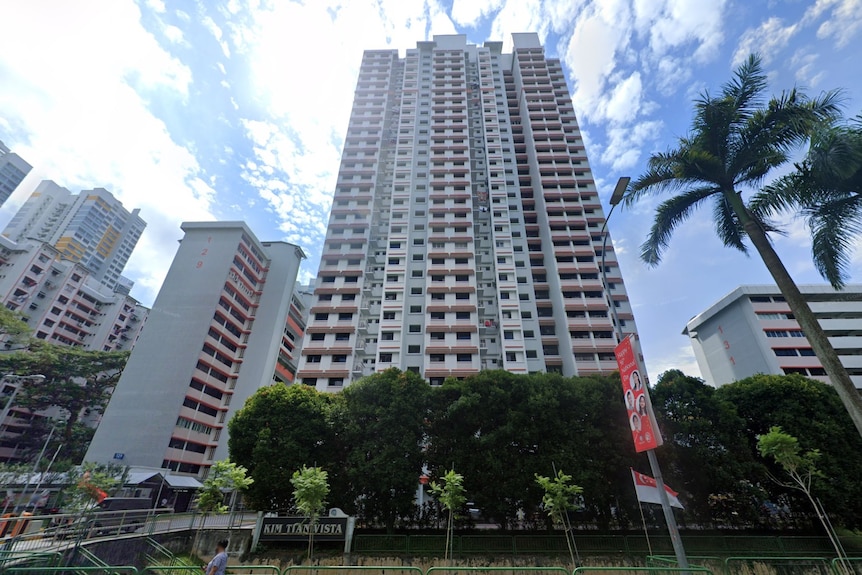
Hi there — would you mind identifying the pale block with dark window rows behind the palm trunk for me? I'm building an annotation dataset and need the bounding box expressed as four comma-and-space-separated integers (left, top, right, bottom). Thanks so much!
683, 285, 862, 389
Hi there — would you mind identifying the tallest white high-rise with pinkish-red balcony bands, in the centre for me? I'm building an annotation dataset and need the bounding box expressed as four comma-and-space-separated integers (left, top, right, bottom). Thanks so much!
298, 34, 635, 390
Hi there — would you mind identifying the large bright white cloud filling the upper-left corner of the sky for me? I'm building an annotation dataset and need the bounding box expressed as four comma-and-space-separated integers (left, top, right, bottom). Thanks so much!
0, 0, 213, 302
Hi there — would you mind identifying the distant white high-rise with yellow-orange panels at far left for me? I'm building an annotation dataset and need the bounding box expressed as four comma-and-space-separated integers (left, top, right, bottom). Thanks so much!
3, 180, 147, 293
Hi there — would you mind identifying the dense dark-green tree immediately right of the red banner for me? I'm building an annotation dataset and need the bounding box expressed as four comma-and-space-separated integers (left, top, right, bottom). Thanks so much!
651, 370, 766, 524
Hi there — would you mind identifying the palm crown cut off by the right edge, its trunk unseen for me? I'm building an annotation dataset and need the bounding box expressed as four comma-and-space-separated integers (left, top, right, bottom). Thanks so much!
750, 116, 862, 289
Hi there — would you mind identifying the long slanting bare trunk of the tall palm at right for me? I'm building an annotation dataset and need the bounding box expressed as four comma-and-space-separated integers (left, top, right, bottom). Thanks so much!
724, 191, 862, 435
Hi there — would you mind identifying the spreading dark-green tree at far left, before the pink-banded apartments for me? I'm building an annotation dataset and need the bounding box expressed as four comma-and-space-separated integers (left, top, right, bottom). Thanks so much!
0, 341, 129, 463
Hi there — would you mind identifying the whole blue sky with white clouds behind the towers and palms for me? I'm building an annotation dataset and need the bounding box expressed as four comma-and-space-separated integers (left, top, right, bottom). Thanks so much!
0, 0, 862, 375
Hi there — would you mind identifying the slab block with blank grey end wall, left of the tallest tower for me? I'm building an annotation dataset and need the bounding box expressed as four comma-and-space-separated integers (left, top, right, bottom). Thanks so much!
86, 222, 305, 476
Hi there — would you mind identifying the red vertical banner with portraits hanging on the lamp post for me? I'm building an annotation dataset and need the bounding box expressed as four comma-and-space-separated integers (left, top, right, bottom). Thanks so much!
614, 334, 663, 453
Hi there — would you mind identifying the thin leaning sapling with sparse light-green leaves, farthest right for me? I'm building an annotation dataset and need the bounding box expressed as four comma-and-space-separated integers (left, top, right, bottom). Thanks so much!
757, 426, 852, 573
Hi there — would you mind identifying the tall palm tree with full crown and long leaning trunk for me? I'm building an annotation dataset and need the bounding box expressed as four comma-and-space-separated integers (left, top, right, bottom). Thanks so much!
624, 55, 862, 435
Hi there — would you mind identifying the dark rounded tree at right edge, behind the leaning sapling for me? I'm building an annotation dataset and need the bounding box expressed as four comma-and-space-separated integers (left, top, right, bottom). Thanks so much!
715, 375, 862, 529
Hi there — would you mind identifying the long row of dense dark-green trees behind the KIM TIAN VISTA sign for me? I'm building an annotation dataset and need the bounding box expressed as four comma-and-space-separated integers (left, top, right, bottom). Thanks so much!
230, 370, 862, 528
